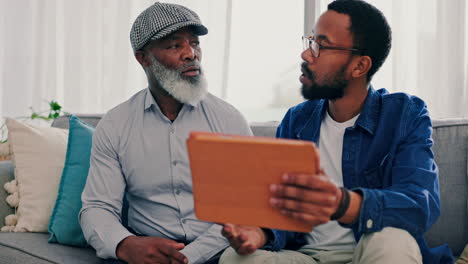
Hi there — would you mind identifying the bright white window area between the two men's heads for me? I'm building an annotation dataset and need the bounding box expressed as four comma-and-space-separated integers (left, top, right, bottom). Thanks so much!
179, 0, 304, 121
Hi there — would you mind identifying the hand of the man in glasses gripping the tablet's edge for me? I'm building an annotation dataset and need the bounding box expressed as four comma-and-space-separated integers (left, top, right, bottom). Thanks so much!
270, 171, 342, 226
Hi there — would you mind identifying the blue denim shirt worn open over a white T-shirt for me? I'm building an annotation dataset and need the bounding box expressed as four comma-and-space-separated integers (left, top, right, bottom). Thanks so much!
269, 87, 453, 264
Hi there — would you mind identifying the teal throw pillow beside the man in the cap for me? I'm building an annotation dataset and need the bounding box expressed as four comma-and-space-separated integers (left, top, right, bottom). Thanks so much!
49, 115, 94, 246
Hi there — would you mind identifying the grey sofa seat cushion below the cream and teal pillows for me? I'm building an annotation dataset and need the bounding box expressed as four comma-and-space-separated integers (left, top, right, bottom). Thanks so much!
0, 233, 102, 264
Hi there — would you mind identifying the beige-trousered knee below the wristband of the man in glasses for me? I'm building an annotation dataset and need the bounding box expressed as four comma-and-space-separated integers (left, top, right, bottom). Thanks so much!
358, 227, 422, 263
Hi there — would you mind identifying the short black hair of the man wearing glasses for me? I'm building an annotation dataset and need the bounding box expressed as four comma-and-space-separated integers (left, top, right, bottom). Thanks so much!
328, 0, 392, 82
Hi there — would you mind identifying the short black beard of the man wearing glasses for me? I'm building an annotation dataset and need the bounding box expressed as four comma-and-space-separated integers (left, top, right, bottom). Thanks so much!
301, 62, 348, 100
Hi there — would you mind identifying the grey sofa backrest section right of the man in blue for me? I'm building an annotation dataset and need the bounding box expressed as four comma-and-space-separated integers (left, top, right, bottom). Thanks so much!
425, 119, 468, 255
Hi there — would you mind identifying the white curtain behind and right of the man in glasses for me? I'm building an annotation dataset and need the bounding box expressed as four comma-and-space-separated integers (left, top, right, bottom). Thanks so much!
319, 0, 468, 118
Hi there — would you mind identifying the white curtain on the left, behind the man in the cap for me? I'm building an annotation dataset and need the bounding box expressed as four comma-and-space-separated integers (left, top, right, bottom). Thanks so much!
0, 0, 226, 117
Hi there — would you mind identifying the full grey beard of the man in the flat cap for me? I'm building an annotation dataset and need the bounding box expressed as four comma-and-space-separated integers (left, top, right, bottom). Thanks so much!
147, 54, 208, 105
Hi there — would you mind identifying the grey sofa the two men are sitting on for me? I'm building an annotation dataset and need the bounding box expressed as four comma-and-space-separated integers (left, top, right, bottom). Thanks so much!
0, 115, 468, 264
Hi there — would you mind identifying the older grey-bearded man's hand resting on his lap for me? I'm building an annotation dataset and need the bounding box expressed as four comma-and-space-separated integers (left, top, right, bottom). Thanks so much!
117, 236, 188, 264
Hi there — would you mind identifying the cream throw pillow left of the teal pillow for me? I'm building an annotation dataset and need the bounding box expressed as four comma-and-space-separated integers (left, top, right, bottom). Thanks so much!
6, 118, 68, 232
